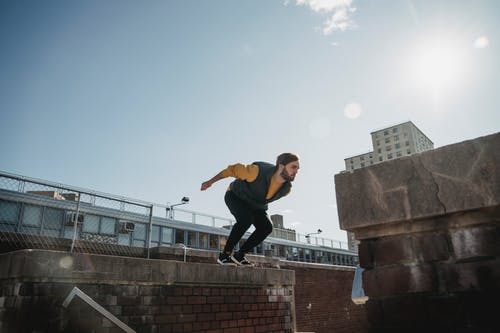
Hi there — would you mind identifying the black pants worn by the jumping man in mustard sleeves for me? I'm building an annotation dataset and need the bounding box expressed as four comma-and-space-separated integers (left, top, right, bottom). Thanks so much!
224, 191, 273, 253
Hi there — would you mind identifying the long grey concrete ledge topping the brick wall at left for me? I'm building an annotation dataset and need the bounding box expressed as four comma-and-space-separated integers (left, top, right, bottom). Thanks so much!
0, 250, 295, 286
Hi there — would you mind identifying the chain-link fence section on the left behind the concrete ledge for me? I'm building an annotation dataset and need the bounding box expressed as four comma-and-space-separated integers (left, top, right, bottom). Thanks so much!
0, 174, 152, 257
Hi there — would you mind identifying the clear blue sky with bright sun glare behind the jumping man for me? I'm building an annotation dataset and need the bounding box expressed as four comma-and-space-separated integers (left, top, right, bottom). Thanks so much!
0, 0, 500, 240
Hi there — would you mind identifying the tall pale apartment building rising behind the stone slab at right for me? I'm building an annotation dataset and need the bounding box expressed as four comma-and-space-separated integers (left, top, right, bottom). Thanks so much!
344, 121, 434, 251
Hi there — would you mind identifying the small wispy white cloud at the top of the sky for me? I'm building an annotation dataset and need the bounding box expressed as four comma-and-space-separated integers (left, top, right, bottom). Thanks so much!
297, 0, 356, 35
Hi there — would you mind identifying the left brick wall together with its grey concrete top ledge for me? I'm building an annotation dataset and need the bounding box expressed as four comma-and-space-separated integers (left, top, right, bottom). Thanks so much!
0, 250, 295, 333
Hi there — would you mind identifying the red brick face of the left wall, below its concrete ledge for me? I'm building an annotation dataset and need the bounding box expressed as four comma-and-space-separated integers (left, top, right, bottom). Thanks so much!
0, 282, 293, 333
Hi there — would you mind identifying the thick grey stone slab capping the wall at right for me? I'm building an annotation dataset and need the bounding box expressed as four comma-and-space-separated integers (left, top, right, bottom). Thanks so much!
335, 133, 500, 231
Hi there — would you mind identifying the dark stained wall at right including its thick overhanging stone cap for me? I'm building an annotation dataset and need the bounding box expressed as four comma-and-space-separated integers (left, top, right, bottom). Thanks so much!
335, 133, 500, 332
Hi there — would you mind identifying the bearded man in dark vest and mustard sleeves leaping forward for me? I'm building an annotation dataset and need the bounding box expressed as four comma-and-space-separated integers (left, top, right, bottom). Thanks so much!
201, 153, 299, 265
